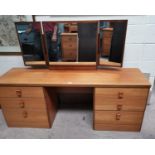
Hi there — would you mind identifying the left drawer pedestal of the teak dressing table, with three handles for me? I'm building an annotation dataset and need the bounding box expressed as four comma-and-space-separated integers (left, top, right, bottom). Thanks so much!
0, 87, 55, 128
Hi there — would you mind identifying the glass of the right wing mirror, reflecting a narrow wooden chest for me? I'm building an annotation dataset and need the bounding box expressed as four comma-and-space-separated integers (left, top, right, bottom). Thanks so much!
99, 20, 127, 66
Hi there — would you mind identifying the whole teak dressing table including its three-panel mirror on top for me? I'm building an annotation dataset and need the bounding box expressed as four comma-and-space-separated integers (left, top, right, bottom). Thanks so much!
0, 20, 150, 131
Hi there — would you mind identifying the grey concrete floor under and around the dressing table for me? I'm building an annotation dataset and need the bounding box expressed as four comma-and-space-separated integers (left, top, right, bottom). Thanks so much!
0, 87, 155, 139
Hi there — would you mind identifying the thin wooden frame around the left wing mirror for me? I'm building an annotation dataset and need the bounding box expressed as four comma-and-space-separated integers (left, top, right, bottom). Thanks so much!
14, 21, 48, 67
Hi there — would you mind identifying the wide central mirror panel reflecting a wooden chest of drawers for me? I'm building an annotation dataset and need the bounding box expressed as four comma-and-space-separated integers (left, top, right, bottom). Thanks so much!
42, 21, 98, 66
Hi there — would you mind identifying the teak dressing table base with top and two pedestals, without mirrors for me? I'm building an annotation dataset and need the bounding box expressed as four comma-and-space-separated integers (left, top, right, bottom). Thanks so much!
0, 68, 150, 131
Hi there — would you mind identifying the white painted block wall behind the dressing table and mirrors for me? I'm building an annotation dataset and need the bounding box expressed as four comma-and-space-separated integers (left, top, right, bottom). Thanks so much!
0, 16, 155, 88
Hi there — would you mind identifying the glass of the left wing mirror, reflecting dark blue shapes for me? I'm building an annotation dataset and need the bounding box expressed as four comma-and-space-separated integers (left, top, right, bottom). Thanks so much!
16, 22, 45, 65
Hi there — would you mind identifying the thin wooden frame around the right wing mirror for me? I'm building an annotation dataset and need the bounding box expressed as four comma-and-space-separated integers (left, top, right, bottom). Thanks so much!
97, 20, 128, 68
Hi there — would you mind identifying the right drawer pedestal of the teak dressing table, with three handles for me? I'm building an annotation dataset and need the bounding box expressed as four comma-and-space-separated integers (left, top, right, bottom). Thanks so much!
94, 88, 149, 131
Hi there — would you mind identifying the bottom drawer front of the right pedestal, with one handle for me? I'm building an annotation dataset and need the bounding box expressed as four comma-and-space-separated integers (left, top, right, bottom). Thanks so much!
94, 111, 143, 125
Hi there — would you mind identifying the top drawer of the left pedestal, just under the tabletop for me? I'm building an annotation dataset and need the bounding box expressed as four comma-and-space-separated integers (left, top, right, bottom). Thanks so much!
0, 87, 44, 97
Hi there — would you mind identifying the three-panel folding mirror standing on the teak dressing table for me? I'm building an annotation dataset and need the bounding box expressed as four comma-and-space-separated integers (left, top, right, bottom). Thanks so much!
15, 20, 127, 67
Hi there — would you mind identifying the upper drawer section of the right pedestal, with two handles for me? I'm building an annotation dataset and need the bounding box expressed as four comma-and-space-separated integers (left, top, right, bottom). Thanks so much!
94, 88, 149, 111
